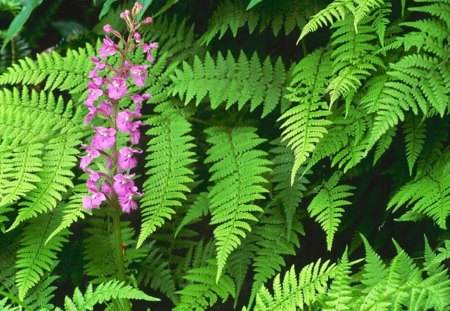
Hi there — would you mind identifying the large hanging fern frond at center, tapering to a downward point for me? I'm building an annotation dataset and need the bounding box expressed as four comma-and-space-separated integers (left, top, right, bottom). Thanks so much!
205, 127, 271, 281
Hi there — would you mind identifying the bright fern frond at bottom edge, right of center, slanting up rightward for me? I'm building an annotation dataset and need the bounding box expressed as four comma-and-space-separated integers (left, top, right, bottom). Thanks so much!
255, 259, 336, 311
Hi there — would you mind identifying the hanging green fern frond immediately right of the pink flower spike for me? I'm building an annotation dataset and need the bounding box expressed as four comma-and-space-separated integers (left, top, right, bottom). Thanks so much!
137, 112, 195, 247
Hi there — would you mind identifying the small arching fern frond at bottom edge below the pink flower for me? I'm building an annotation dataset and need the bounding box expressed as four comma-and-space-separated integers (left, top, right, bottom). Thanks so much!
60, 281, 159, 311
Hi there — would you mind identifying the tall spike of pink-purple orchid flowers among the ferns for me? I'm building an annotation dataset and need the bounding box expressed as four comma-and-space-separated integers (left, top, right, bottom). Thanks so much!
80, 3, 158, 213
